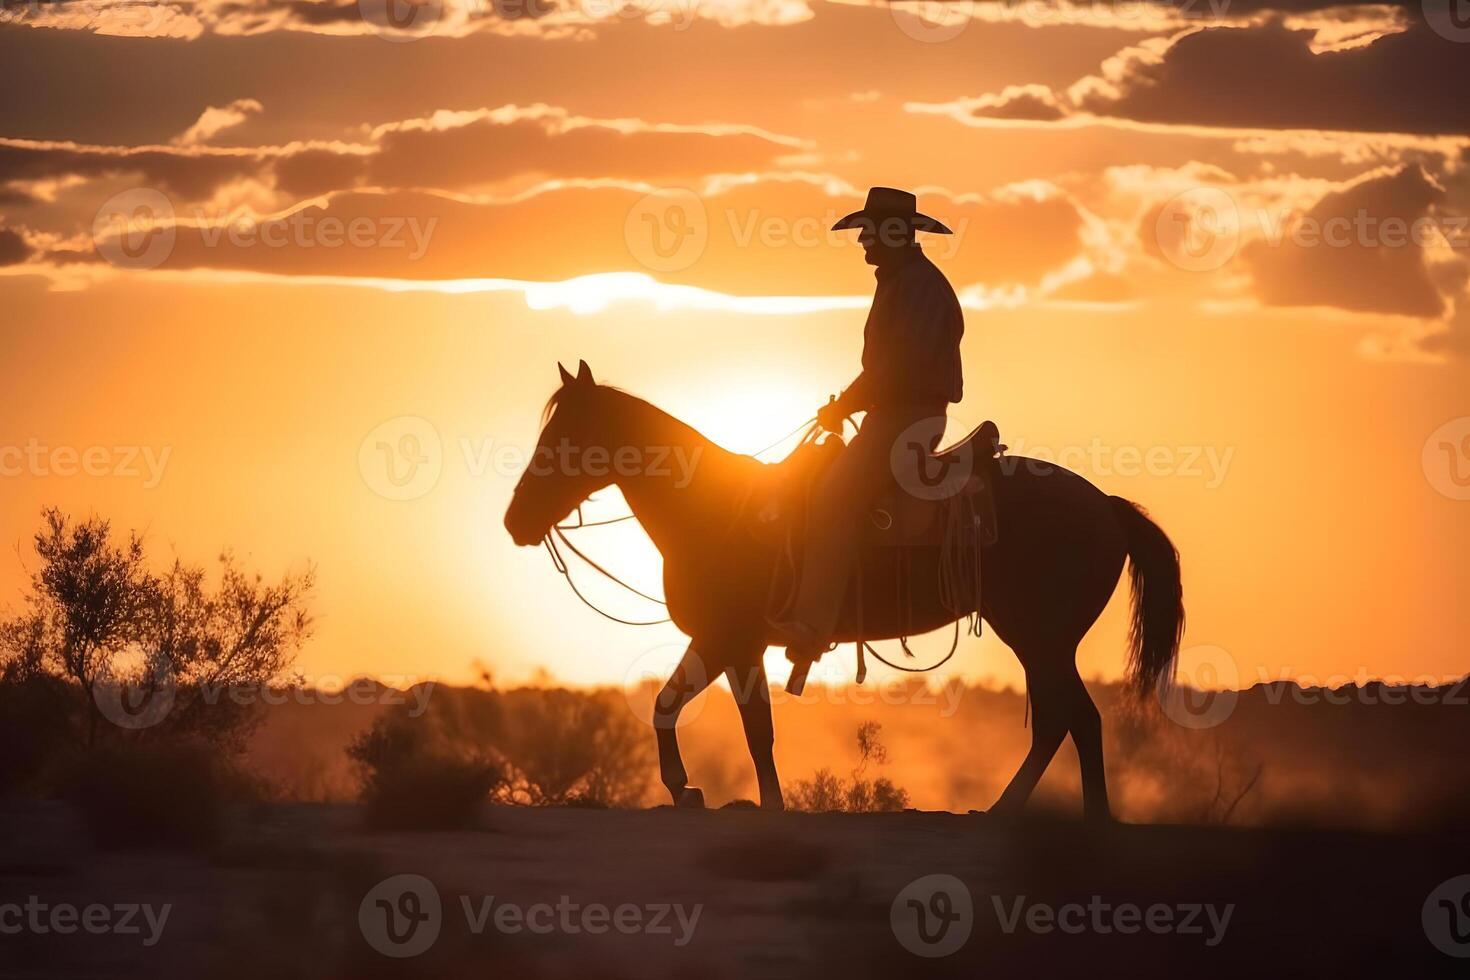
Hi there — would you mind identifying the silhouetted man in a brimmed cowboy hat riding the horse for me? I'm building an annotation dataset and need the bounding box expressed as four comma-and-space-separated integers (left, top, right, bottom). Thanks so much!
773, 187, 964, 677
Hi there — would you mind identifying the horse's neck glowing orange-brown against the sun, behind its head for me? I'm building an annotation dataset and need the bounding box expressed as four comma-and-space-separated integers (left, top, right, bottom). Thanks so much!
609, 392, 759, 555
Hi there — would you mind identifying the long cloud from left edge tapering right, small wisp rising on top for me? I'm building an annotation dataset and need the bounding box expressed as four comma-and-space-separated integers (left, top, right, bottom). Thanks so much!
0, 100, 810, 206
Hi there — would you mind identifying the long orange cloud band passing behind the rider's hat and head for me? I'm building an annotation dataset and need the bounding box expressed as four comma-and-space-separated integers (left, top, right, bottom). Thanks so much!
77, 175, 1082, 295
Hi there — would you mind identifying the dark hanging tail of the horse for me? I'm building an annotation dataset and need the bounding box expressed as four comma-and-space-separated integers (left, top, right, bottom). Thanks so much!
1108, 497, 1185, 693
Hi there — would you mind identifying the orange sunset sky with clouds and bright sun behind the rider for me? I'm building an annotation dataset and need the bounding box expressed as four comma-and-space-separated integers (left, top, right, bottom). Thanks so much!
0, 0, 1470, 686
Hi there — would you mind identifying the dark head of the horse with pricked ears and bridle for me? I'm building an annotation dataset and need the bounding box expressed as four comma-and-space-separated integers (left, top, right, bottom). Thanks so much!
506, 361, 613, 545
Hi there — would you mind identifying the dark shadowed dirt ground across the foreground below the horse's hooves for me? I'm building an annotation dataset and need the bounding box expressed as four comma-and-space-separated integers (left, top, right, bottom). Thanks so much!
0, 804, 1470, 980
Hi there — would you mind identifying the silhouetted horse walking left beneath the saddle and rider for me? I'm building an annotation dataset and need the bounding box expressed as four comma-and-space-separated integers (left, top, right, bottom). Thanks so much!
504, 361, 1183, 821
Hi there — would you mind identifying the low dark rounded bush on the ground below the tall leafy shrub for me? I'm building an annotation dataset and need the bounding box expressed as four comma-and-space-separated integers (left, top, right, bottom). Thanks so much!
62, 742, 250, 848
